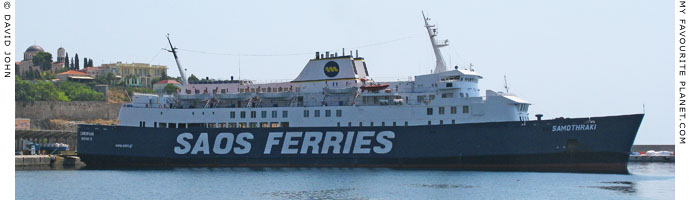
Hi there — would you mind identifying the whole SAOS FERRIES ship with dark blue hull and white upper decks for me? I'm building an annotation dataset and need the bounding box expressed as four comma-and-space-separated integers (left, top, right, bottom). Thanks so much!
78, 15, 643, 174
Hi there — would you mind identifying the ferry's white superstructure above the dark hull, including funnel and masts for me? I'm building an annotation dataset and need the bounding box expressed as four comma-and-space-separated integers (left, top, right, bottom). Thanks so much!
118, 13, 530, 128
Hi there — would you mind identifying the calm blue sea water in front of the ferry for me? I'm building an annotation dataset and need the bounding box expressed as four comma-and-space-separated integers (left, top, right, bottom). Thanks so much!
15, 163, 675, 199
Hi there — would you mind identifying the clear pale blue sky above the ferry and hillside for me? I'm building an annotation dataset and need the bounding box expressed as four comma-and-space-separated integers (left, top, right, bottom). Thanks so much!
15, 0, 674, 144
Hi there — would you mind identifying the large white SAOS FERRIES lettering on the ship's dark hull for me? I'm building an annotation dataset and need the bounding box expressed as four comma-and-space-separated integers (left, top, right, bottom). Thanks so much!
173, 131, 395, 155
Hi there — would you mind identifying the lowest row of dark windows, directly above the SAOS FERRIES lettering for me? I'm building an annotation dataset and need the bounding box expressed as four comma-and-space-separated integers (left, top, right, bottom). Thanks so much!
153, 122, 290, 128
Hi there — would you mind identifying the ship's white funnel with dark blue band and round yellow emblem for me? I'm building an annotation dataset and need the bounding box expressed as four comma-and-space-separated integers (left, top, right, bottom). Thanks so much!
292, 52, 369, 83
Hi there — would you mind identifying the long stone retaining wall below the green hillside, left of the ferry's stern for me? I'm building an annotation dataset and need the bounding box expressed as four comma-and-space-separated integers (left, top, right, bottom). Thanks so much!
14, 101, 121, 122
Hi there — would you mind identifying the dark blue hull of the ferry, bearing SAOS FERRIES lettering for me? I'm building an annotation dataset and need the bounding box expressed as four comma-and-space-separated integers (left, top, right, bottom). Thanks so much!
78, 114, 643, 173
